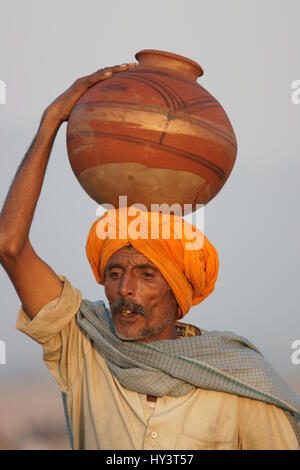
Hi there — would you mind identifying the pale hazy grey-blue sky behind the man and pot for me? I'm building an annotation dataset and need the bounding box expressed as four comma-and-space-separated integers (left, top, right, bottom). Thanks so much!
0, 0, 300, 388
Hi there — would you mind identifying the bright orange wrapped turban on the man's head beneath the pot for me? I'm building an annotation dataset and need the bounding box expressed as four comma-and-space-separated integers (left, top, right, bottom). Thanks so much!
86, 206, 219, 318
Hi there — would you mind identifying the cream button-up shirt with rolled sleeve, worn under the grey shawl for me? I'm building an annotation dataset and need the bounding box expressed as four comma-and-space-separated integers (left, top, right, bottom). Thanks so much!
16, 276, 299, 450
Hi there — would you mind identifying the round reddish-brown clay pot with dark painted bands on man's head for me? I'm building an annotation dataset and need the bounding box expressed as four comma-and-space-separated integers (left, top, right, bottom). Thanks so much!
67, 49, 237, 209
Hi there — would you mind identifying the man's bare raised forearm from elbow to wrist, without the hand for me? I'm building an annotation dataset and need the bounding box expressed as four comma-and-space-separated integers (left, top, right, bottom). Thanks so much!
0, 112, 60, 252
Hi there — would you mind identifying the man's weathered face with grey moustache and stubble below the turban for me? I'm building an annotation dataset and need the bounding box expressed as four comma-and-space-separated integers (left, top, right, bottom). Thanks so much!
104, 245, 177, 343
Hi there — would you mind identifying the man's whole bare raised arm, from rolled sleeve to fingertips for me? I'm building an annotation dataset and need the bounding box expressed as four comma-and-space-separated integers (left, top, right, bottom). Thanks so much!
0, 63, 136, 319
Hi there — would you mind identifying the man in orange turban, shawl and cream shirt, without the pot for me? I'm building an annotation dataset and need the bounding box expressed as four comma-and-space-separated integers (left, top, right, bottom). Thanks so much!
0, 64, 300, 450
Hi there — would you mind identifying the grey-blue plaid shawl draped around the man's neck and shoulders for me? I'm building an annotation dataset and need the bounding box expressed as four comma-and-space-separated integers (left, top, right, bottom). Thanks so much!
77, 299, 300, 445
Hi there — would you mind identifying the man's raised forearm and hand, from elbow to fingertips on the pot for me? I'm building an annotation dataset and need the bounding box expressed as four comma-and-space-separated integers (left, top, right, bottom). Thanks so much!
0, 63, 136, 255
